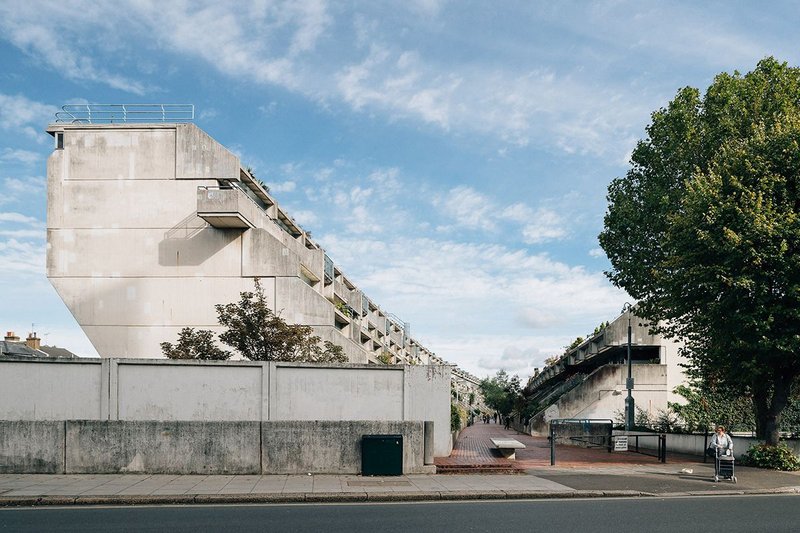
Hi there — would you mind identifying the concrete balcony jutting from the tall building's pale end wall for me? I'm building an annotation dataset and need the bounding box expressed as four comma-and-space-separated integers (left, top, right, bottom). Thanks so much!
197, 187, 260, 229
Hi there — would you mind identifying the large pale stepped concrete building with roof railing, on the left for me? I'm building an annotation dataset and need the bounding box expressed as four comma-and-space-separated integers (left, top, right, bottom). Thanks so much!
47, 110, 440, 364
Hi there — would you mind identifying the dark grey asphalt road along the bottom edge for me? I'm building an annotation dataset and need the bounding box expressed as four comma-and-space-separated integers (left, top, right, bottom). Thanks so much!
0, 495, 800, 533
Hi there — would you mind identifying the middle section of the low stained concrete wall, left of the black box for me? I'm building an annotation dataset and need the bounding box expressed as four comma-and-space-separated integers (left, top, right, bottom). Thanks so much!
65, 420, 261, 474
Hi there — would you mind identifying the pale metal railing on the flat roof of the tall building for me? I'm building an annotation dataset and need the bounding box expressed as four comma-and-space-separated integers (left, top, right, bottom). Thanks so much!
56, 104, 194, 124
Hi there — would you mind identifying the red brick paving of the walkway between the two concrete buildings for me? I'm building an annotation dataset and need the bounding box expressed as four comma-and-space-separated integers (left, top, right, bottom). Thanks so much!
435, 422, 697, 469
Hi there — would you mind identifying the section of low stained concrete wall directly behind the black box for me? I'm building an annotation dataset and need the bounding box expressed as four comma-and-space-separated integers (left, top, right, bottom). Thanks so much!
261, 420, 424, 474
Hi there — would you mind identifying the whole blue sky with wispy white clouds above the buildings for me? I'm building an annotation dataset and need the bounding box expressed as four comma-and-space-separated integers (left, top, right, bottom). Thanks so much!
0, 0, 800, 378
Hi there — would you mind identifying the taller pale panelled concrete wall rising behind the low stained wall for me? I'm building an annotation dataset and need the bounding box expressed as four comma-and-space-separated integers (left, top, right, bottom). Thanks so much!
0, 358, 451, 456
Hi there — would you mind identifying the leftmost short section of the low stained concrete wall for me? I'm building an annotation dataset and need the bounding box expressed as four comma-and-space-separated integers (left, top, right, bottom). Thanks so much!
0, 420, 64, 474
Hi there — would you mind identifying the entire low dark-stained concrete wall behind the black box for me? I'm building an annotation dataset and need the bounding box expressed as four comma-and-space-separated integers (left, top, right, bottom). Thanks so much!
0, 420, 425, 474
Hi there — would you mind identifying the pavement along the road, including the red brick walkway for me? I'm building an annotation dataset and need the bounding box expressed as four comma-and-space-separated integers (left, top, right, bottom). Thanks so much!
0, 424, 800, 506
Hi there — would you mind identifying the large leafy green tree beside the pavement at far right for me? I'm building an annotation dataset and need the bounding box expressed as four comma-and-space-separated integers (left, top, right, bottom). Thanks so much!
600, 58, 800, 444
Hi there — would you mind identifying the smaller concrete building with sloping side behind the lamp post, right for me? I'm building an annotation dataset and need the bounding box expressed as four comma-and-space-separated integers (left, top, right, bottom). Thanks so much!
524, 313, 686, 434
